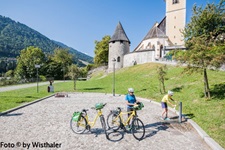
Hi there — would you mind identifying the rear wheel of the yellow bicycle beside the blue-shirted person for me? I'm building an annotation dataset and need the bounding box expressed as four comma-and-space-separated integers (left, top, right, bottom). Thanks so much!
107, 113, 121, 131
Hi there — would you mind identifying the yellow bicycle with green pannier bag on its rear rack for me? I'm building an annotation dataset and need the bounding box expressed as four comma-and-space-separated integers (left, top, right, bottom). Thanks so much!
70, 103, 108, 139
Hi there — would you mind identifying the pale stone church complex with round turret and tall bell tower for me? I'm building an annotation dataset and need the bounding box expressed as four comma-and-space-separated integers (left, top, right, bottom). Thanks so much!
108, 0, 186, 72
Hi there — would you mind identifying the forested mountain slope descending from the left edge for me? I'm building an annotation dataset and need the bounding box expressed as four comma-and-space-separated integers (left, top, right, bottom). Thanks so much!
0, 15, 93, 65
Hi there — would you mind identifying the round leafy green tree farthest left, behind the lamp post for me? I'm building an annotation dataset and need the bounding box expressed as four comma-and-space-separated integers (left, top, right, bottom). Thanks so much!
15, 46, 45, 80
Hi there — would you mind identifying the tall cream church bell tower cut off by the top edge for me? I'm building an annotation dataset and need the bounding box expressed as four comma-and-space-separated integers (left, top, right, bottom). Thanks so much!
165, 0, 186, 47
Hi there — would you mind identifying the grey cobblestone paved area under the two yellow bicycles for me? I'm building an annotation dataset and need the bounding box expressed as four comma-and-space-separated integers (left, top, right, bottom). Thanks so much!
0, 93, 210, 150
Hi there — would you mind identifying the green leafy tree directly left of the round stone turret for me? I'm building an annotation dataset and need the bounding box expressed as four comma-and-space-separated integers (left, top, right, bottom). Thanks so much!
94, 35, 111, 65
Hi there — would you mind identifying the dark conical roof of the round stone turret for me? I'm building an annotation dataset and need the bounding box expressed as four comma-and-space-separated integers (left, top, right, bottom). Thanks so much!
109, 22, 130, 44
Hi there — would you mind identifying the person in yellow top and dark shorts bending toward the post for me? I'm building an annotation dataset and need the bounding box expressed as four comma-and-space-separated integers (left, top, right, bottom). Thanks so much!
161, 91, 175, 120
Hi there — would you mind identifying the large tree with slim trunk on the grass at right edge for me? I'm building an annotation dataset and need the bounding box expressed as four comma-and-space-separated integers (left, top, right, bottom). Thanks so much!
174, 0, 225, 98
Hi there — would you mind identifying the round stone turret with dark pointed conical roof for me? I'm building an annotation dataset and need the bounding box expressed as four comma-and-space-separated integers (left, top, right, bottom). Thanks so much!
108, 22, 130, 72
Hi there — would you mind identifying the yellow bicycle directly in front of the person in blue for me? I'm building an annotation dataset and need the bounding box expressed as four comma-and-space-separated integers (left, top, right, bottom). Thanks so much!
107, 103, 145, 141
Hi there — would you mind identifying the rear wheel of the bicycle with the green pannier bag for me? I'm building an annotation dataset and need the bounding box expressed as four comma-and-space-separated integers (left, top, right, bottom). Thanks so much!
70, 116, 87, 134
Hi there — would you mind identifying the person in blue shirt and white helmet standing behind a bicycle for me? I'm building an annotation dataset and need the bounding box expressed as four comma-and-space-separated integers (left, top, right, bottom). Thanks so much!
125, 88, 139, 128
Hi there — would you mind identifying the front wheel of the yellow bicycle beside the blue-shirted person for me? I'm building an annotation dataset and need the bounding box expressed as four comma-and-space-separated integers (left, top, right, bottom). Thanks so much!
131, 118, 145, 140
